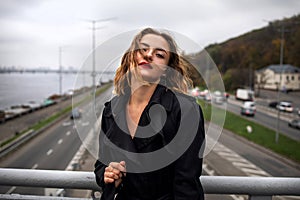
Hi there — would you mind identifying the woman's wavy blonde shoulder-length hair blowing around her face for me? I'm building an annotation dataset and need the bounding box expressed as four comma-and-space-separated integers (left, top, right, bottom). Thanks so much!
114, 28, 192, 95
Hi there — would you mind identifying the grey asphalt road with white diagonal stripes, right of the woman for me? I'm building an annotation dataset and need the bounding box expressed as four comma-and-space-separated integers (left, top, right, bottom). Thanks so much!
203, 122, 300, 200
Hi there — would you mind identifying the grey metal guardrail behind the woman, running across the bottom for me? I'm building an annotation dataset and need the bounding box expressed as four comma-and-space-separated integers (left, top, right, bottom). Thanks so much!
0, 168, 300, 200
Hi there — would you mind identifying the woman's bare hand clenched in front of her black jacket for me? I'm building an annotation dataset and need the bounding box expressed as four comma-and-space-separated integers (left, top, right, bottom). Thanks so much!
104, 161, 126, 187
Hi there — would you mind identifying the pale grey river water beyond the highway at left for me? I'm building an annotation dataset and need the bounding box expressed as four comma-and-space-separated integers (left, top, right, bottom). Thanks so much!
0, 73, 112, 109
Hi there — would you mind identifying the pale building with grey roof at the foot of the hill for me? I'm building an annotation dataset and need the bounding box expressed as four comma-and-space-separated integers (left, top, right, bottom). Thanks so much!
255, 64, 300, 91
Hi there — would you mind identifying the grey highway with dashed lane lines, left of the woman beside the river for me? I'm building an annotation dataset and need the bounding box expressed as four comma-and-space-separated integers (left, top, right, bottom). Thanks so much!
0, 86, 111, 195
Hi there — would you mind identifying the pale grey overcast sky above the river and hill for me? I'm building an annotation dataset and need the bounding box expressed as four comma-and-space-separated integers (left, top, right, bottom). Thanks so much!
0, 0, 300, 68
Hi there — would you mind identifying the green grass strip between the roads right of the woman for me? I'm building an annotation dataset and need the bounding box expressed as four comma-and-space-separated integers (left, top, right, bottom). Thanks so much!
198, 100, 300, 163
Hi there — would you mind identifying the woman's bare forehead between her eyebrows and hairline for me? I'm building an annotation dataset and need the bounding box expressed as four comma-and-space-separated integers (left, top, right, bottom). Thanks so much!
140, 34, 170, 51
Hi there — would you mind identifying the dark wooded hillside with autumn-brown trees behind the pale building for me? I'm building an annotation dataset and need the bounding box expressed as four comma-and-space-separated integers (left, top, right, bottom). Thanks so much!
189, 15, 300, 90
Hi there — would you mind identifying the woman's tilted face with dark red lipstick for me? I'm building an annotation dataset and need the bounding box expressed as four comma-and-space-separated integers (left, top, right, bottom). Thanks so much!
135, 34, 170, 83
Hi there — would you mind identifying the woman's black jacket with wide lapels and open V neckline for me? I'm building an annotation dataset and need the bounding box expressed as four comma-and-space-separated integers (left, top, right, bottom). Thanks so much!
94, 85, 205, 200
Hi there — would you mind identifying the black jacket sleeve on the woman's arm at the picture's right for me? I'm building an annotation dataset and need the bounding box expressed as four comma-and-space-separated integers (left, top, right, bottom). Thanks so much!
174, 103, 205, 200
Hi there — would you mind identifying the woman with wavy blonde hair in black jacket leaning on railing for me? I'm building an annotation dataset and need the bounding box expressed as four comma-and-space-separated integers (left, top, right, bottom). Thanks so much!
94, 28, 205, 200
